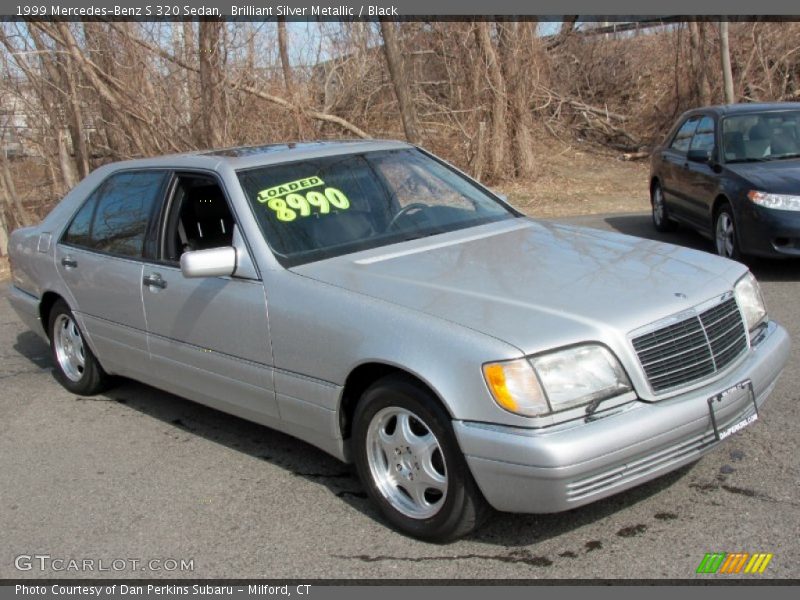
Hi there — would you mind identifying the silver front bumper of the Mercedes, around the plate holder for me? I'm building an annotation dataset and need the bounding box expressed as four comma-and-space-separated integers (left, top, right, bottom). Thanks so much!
453, 322, 790, 513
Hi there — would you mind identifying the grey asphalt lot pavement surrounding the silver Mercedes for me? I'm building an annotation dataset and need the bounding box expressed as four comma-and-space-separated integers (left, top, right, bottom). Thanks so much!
0, 214, 800, 578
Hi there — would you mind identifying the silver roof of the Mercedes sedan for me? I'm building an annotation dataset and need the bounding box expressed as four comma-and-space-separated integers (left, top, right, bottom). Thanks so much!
95, 140, 414, 171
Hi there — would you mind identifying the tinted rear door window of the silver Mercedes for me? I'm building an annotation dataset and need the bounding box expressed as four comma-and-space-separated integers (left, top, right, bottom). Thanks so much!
64, 171, 166, 258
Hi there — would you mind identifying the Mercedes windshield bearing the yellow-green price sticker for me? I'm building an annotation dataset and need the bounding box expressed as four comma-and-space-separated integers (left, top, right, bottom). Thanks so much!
238, 149, 518, 267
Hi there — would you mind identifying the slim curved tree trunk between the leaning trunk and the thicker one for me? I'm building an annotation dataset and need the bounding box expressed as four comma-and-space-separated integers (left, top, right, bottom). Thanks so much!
475, 21, 508, 179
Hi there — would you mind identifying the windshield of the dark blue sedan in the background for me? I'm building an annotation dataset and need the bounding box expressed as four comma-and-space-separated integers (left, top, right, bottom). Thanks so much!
722, 111, 800, 163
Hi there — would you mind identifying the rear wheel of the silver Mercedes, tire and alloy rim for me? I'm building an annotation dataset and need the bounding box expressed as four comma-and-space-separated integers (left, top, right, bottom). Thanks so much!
49, 300, 109, 396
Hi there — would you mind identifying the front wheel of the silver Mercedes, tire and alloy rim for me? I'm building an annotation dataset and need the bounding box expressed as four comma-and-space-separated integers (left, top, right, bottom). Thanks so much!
353, 375, 488, 542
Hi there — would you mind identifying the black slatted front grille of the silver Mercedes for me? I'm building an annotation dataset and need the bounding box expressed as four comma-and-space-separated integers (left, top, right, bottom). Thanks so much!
633, 298, 747, 392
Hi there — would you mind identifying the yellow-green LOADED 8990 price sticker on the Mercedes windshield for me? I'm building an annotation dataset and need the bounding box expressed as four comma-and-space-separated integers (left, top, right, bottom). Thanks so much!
257, 177, 350, 223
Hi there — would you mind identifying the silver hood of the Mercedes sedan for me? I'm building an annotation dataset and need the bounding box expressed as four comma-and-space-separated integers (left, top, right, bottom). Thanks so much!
292, 219, 746, 354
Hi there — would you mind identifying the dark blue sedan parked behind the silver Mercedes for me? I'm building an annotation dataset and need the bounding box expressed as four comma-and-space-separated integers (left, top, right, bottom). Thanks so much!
650, 102, 800, 259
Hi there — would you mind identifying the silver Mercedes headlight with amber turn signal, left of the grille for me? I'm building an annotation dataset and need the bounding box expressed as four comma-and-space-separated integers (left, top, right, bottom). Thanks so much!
483, 344, 632, 417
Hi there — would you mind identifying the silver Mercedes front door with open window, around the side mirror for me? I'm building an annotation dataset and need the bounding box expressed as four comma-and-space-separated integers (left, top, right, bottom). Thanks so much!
139, 172, 278, 424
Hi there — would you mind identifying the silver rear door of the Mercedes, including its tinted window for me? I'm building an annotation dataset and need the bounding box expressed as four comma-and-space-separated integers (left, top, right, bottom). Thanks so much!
55, 170, 168, 378
